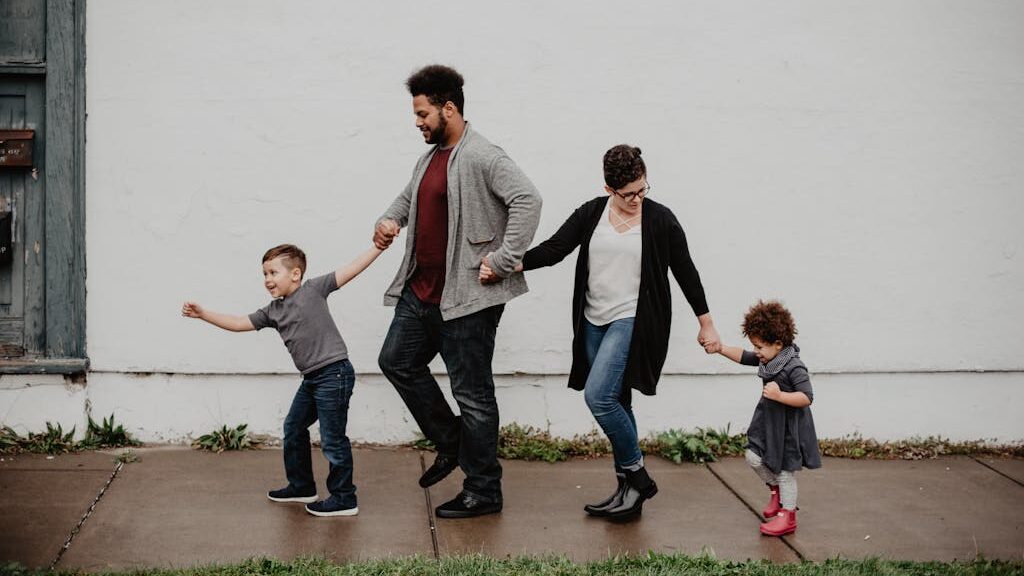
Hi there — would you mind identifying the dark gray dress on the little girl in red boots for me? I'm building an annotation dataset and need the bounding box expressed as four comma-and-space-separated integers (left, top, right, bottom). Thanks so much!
740, 344, 821, 475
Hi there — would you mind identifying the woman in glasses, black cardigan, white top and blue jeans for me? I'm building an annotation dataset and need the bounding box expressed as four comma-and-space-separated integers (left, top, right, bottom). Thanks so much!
480, 145, 719, 519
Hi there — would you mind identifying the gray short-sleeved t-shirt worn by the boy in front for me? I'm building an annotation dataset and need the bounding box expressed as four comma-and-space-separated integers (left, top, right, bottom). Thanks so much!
249, 272, 348, 374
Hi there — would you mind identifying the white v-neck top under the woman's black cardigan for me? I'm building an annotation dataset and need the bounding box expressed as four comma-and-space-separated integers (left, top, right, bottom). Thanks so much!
584, 197, 642, 326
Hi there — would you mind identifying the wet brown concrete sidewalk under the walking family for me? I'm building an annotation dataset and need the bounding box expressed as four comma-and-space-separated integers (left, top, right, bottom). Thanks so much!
0, 448, 1024, 570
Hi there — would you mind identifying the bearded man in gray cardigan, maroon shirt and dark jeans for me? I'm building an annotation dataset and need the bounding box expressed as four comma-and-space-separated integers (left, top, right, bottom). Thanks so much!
374, 66, 541, 518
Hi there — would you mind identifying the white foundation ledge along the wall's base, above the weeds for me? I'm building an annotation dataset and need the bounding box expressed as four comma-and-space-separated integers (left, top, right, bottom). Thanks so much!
0, 372, 1024, 444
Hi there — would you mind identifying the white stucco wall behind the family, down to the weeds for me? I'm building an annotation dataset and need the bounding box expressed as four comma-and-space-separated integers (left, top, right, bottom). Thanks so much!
8, 0, 1024, 441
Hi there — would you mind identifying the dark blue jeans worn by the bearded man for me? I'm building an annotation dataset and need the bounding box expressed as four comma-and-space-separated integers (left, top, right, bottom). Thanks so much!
379, 286, 505, 502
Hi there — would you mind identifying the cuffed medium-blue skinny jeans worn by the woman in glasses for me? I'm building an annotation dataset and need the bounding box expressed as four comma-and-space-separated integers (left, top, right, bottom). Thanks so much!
583, 318, 642, 470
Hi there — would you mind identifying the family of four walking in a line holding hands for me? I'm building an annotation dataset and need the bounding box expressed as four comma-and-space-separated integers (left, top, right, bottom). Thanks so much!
181, 66, 820, 536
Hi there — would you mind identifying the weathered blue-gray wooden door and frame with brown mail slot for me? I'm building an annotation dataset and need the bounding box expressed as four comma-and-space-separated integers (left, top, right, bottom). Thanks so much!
0, 0, 88, 373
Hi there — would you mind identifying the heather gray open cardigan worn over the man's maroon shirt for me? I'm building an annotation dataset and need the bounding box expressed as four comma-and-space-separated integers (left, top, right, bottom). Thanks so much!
378, 123, 541, 320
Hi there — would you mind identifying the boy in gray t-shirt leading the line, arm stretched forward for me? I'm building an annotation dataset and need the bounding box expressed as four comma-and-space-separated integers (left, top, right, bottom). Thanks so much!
181, 244, 381, 517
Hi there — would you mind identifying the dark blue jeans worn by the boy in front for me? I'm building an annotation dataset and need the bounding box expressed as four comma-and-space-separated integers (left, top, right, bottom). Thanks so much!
285, 360, 356, 507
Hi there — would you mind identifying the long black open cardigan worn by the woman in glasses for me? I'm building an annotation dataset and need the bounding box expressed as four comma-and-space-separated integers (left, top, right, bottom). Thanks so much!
522, 196, 708, 398
